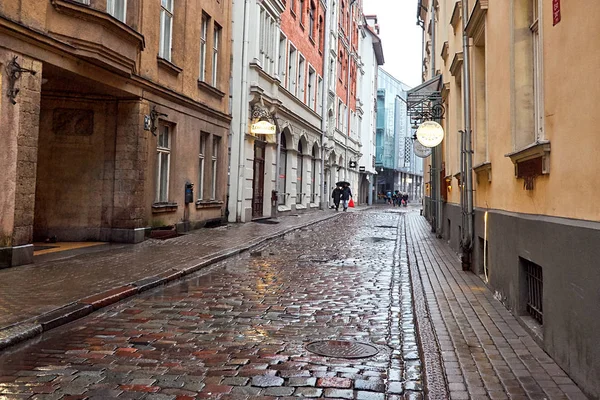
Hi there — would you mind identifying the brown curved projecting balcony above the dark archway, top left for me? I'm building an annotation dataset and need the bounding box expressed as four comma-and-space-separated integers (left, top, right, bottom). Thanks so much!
47, 0, 144, 76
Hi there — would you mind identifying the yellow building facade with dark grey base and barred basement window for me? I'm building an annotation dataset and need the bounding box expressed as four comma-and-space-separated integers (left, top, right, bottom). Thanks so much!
418, 0, 600, 398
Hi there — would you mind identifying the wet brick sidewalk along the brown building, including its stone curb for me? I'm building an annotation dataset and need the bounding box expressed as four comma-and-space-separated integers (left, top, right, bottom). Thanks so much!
0, 207, 346, 349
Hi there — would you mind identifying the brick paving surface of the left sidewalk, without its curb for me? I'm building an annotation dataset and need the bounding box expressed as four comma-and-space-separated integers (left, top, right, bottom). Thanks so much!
0, 211, 334, 330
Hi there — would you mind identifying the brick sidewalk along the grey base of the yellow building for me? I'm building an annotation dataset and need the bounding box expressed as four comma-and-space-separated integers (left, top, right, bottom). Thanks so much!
405, 212, 587, 400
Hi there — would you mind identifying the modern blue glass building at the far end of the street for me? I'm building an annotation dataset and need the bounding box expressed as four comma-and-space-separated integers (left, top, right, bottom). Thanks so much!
375, 67, 423, 201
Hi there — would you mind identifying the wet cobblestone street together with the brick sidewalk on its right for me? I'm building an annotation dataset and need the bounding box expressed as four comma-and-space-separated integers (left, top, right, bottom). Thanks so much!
0, 208, 585, 400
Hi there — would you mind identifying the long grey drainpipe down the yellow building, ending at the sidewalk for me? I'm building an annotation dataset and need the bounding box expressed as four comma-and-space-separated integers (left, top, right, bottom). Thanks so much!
461, 0, 474, 270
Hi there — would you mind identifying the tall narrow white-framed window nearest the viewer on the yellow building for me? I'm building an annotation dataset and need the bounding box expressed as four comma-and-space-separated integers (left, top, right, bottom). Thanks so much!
529, 0, 544, 140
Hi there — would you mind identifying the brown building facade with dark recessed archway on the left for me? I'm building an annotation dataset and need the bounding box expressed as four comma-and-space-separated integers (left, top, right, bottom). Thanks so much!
0, 0, 231, 266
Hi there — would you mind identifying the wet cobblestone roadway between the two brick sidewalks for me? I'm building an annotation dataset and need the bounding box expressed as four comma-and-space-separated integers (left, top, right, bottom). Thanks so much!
0, 213, 422, 400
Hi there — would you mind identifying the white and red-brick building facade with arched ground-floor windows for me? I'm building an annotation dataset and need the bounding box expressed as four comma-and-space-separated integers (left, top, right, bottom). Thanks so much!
229, 0, 362, 222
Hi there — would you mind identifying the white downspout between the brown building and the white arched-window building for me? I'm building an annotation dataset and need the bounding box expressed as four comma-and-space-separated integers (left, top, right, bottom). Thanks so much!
235, 0, 250, 222
